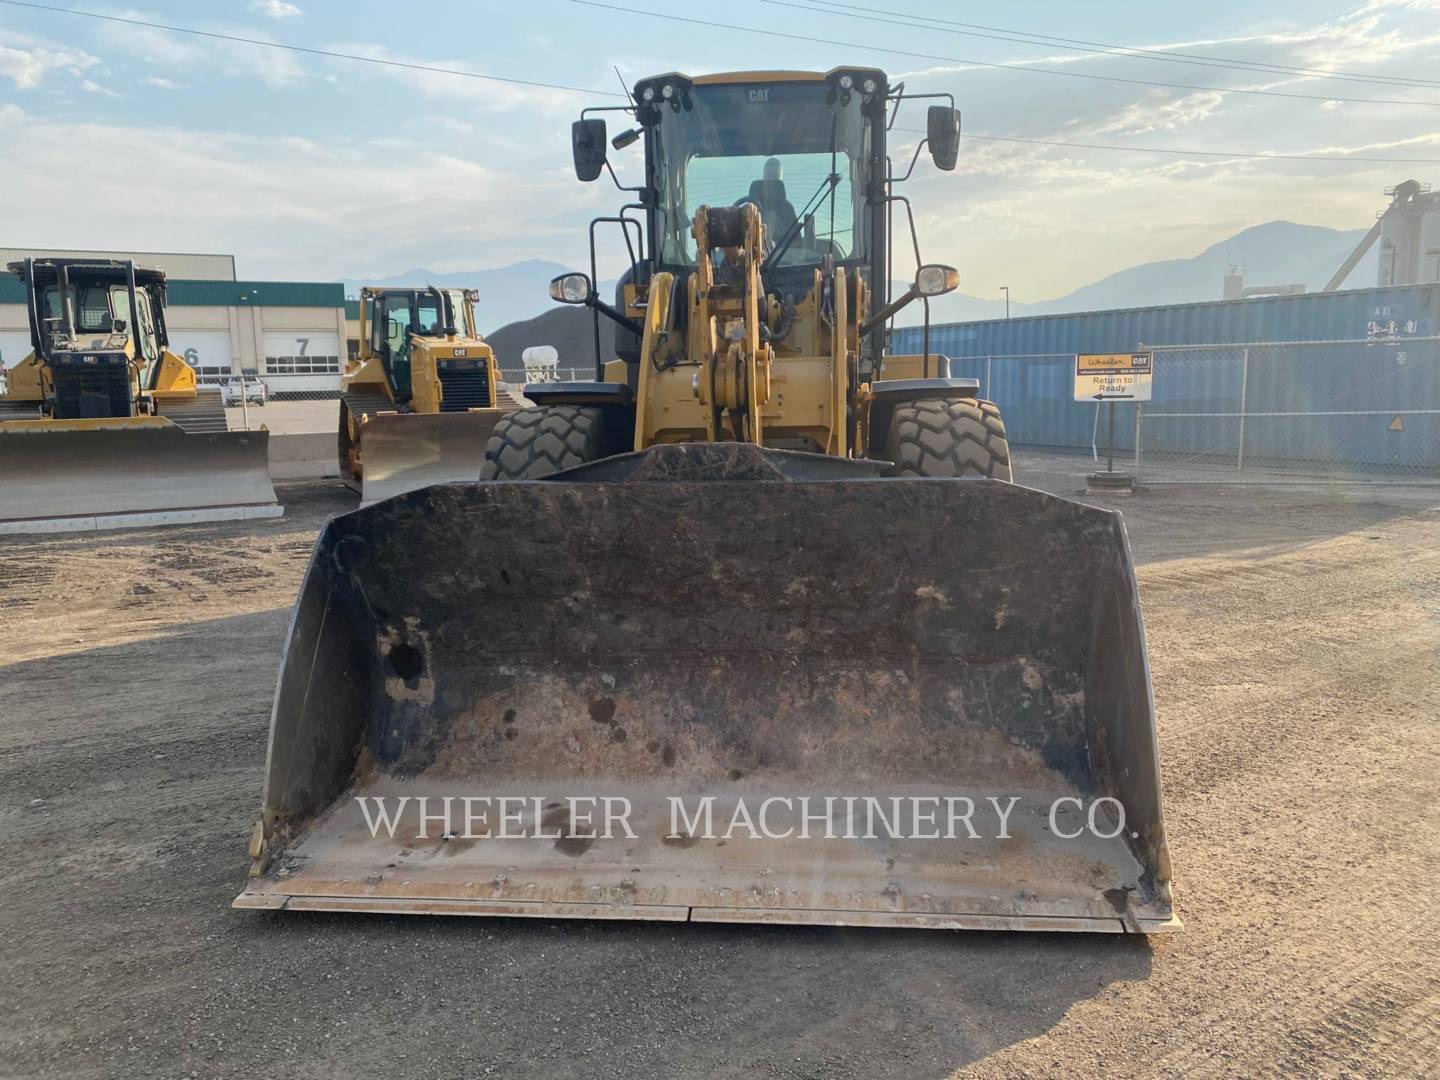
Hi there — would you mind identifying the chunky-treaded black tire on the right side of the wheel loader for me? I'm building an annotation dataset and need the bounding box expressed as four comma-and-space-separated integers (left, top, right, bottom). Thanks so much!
886, 399, 1012, 481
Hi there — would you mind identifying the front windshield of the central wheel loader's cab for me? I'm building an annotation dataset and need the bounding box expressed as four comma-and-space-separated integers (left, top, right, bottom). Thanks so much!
655, 81, 870, 266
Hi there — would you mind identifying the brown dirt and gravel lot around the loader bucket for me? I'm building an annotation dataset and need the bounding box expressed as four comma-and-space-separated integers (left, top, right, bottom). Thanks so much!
0, 459, 1440, 1080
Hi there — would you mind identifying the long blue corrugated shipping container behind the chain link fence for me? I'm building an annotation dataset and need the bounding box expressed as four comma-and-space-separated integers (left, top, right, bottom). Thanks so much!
893, 285, 1440, 467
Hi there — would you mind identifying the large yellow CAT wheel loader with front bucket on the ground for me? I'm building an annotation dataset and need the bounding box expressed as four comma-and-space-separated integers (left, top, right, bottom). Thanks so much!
235, 68, 1179, 933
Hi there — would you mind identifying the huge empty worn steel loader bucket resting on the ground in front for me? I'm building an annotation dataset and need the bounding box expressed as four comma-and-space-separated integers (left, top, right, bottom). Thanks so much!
235, 444, 1179, 932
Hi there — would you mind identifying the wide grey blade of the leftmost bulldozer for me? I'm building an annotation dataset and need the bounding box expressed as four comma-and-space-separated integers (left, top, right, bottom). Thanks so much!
0, 418, 284, 534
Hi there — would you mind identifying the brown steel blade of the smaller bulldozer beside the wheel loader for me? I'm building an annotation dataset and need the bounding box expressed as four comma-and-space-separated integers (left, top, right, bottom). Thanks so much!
351, 409, 505, 507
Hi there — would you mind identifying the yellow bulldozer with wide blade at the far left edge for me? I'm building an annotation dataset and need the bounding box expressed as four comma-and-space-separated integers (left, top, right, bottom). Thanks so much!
0, 258, 284, 533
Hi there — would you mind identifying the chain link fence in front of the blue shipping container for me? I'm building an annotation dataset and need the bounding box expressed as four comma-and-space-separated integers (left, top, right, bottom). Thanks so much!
950, 336, 1440, 484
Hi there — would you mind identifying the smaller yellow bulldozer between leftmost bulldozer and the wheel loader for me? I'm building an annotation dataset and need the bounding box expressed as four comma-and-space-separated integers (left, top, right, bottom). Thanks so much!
340, 287, 520, 505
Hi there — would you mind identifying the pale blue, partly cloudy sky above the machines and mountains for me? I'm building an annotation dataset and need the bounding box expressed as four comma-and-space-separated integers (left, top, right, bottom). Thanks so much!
0, 0, 1440, 301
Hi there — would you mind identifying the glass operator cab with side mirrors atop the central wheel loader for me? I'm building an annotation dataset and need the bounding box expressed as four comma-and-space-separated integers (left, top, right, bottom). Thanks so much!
552, 68, 960, 379
